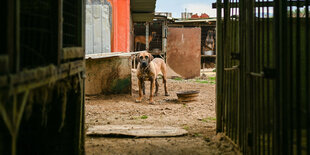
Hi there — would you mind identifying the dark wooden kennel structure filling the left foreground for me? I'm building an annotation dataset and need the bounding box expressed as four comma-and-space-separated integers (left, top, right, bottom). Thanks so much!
0, 0, 85, 155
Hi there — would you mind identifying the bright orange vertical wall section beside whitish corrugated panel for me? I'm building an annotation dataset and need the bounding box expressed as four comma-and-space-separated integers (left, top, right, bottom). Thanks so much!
108, 0, 130, 52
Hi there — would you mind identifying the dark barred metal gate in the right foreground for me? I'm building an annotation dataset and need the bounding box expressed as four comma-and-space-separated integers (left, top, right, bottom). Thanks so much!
214, 0, 310, 154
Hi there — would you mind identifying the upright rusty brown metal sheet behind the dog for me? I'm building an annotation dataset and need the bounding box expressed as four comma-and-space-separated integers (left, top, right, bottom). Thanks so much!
167, 28, 201, 78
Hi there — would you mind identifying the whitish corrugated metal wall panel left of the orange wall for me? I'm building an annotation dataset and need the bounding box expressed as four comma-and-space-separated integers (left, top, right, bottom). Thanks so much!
85, 1, 112, 54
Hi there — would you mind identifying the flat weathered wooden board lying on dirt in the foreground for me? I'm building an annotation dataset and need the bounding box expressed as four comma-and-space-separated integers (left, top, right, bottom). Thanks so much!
86, 125, 188, 137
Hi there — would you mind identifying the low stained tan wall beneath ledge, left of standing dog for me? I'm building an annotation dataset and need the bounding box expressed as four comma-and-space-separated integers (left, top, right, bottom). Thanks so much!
85, 56, 131, 95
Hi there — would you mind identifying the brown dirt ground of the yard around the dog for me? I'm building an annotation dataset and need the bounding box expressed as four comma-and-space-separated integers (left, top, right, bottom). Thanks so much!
85, 69, 239, 155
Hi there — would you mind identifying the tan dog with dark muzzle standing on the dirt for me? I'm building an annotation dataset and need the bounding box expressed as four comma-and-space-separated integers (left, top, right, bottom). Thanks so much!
136, 51, 169, 104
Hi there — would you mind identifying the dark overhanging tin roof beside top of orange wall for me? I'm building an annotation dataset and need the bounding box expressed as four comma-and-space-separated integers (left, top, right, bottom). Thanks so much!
130, 0, 156, 22
